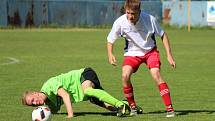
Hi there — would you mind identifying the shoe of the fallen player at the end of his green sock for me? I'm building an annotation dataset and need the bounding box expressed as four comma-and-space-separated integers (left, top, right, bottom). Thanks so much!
116, 104, 130, 117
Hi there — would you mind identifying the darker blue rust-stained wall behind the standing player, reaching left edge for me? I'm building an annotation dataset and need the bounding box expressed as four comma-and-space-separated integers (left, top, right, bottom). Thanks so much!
0, 0, 162, 27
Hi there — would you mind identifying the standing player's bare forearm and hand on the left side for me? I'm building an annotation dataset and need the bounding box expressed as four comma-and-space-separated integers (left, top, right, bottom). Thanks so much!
107, 42, 117, 66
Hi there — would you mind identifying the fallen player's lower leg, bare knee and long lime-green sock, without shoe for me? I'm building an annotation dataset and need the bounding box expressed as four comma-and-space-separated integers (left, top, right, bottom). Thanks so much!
84, 88, 124, 107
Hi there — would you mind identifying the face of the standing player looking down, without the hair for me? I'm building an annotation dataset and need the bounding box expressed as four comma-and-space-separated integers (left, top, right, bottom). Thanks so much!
125, 9, 140, 24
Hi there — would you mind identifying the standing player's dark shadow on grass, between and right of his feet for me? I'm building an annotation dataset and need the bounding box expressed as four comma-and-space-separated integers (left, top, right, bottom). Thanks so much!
145, 110, 215, 115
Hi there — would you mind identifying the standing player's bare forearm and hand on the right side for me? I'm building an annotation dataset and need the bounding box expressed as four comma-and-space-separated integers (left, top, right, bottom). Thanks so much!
161, 32, 176, 68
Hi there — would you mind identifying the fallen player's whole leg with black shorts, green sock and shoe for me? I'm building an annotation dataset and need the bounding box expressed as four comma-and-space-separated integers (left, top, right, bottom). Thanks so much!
82, 68, 129, 116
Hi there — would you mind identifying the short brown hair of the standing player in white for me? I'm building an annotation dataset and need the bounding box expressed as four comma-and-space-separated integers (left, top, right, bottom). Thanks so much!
124, 0, 141, 11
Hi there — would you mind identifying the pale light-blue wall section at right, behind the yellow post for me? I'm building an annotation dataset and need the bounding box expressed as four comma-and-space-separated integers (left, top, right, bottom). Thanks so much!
163, 1, 208, 26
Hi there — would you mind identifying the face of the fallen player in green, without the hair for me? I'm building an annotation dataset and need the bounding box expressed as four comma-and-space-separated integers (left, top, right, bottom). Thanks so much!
26, 92, 44, 106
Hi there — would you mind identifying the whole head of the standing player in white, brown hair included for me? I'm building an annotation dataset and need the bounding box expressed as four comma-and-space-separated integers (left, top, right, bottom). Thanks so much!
124, 0, 141, 24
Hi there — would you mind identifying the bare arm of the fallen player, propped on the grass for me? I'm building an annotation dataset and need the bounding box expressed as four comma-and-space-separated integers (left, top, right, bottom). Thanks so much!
57, 88, 73, 118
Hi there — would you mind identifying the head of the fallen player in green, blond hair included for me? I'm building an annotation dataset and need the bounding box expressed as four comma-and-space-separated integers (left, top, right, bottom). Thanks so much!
22, 91, 44, 106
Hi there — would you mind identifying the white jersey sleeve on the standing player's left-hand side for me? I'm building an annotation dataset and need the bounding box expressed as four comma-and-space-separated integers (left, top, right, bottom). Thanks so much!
107, 20, 121, 43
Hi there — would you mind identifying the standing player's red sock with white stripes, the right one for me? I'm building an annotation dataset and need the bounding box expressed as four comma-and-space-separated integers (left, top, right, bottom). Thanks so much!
159, 83, 172, 107
